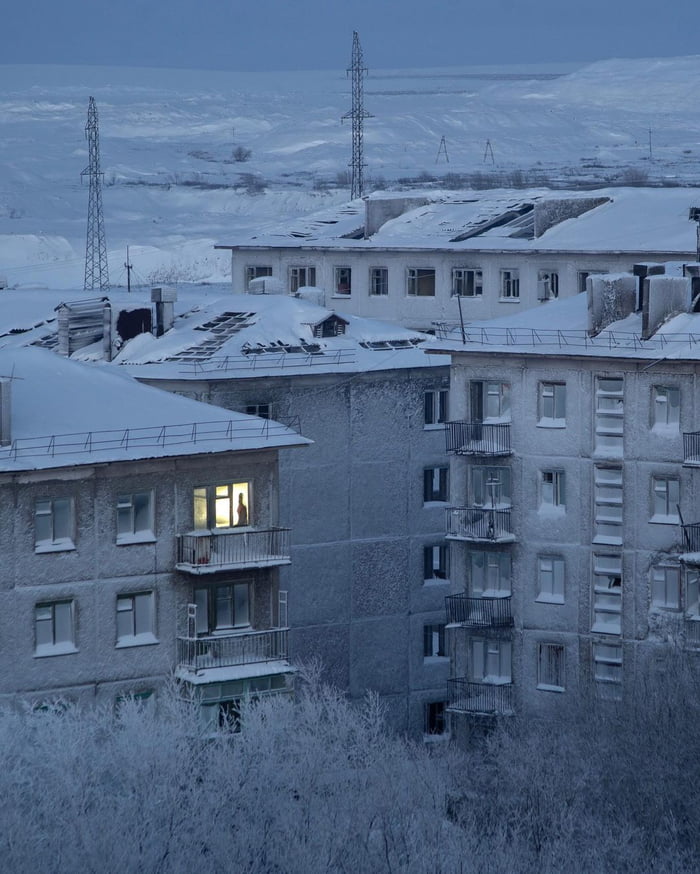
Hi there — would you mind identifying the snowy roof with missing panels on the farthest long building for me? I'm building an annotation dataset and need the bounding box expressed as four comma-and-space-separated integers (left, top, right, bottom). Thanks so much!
224, 187, 700, 255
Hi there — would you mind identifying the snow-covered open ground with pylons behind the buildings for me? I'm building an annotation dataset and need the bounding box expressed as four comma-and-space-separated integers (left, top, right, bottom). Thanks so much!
0, 56, 700, 289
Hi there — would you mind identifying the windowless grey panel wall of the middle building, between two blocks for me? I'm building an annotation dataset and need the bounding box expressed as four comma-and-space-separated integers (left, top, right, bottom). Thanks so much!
148, 364, 449, 734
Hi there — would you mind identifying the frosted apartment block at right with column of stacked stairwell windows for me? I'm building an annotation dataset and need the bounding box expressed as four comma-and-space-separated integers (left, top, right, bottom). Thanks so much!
426, 266, 700, 735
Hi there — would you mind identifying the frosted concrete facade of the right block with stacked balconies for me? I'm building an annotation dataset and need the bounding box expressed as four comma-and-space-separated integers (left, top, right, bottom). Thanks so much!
449, 352, 700, 732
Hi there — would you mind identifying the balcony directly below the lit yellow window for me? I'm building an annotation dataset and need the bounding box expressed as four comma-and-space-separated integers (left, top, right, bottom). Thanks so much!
175, 528, 291, 574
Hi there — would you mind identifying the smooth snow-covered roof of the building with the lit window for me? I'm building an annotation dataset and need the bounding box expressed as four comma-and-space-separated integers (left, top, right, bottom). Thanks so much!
0, 347, 311, 471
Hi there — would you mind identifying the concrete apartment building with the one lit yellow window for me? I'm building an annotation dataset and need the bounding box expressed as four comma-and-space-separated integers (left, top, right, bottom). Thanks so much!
0, 348, 308, 723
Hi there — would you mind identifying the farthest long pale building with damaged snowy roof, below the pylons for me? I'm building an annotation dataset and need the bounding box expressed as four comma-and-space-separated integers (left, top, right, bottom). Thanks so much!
218, 188, 696, 330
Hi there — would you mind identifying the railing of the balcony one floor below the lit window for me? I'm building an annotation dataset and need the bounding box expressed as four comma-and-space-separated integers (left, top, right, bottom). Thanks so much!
177, 628, 287, 671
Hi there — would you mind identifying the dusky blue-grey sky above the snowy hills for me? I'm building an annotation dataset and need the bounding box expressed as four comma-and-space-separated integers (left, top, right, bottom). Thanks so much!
5, 0, 700, 70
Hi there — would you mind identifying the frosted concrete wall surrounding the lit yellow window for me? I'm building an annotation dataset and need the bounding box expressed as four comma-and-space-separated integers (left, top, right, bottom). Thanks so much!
0, 451, 278, 701
